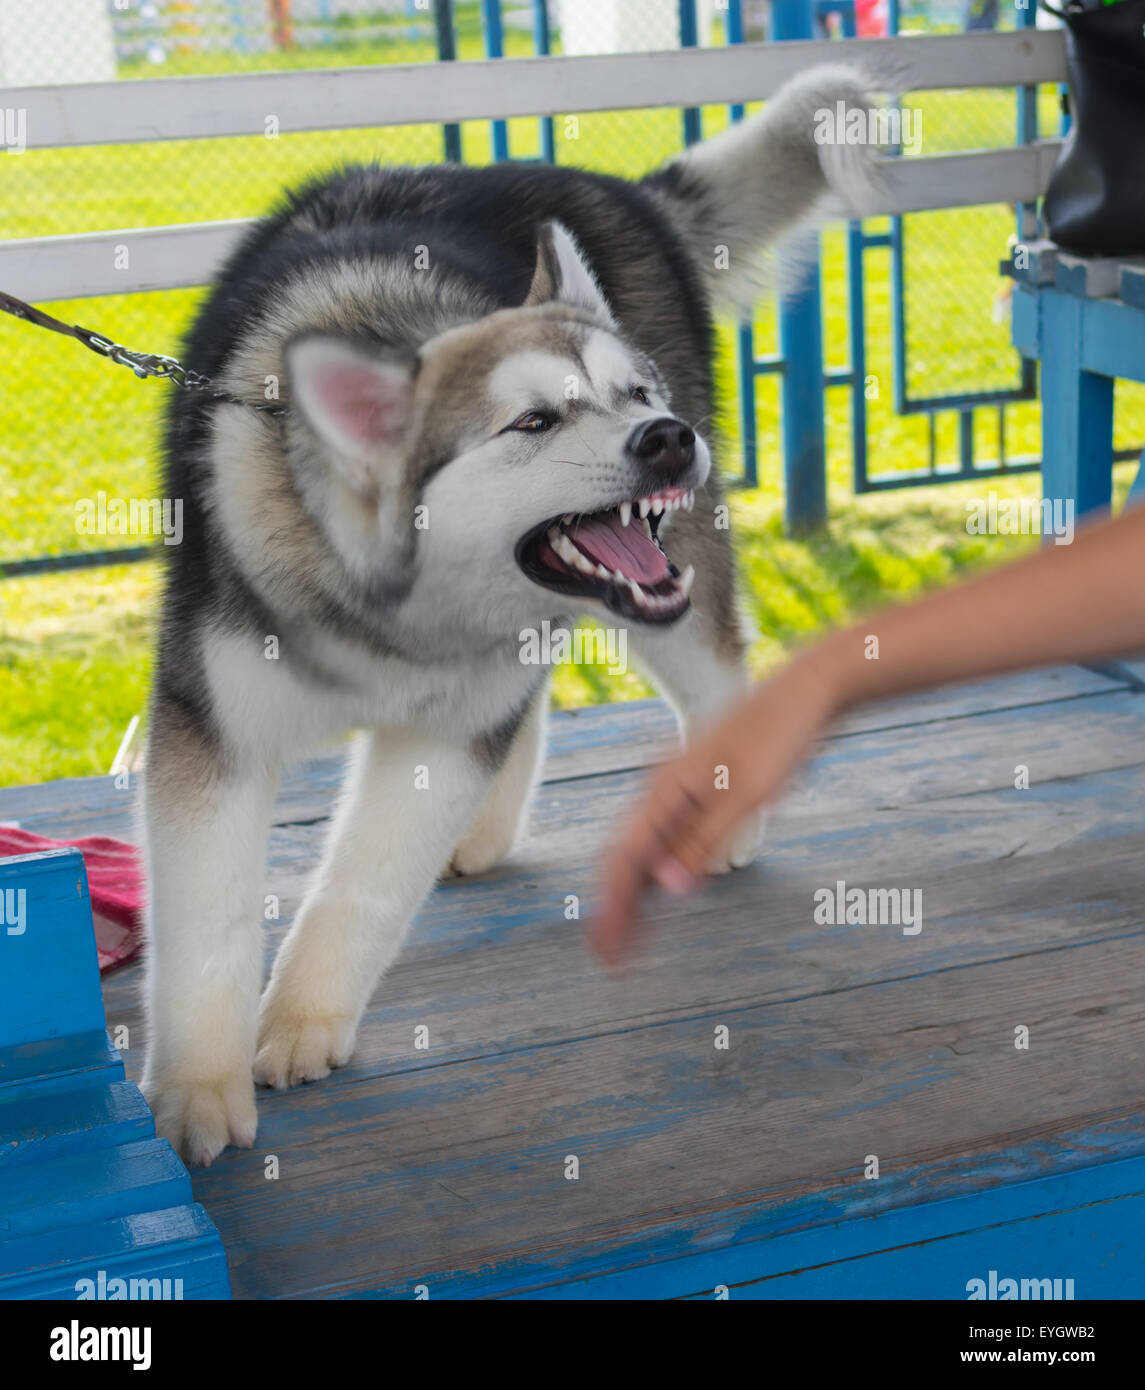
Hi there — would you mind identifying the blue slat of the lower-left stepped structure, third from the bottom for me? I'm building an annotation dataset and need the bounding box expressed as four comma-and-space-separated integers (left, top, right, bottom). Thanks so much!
0, 1081, 156, 1173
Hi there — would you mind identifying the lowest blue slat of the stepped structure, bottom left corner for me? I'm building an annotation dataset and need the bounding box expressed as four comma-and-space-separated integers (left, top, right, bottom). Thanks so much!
0, 1202, 231, 1300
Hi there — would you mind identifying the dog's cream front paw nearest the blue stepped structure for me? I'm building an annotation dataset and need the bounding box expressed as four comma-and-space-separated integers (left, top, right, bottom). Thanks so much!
142, 1068, 258, 1168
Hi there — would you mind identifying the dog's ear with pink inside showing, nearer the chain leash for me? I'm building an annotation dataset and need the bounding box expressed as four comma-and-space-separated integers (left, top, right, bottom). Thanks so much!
286, 335, 415, 493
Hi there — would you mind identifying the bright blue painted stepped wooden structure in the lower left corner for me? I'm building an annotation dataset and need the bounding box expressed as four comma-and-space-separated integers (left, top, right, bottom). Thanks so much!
0, 849, 231, 1300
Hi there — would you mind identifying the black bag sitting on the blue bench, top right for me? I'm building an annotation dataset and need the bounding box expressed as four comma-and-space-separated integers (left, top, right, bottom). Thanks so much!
1042, 0, 1145, 256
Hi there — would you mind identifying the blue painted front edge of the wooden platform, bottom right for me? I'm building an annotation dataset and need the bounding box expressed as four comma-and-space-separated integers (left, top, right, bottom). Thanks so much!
503, 1151, 1145, 1300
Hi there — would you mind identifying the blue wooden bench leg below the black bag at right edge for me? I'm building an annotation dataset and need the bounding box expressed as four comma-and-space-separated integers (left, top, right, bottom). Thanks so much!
1041, 292, 1113, 514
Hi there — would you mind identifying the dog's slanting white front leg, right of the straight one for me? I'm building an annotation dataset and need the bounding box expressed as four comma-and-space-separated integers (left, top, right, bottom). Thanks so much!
254, 728, 495, 1090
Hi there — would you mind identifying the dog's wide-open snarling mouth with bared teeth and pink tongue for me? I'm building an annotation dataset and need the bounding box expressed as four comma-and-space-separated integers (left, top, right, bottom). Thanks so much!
517, 488, 695, 623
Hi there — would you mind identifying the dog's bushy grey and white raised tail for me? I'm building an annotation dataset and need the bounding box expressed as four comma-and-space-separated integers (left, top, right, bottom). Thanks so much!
645, 63, 882, 309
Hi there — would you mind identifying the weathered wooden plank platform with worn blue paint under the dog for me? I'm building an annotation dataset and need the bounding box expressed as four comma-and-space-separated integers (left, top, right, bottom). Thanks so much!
0, 669, 1145, 1297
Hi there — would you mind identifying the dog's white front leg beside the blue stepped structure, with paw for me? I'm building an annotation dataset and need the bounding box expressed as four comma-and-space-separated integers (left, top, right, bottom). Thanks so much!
143, 696, 278, 1163
